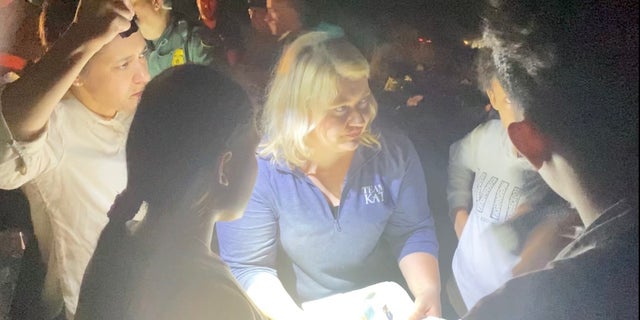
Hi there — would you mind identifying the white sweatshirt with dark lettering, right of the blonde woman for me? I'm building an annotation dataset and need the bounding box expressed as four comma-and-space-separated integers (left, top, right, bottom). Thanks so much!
447, 120, 537, 309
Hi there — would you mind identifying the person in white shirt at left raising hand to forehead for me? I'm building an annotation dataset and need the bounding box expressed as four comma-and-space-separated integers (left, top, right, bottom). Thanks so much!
0, 0, 149, 319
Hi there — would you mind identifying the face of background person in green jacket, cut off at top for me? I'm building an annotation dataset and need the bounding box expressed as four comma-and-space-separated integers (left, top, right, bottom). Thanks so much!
131, 0, 169, 40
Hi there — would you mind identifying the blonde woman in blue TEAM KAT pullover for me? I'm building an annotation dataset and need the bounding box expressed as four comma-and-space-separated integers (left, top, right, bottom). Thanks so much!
217, 32, 440, 319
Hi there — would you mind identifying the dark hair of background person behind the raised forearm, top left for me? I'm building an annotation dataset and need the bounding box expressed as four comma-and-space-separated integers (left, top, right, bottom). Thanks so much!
38, 0, 79, 49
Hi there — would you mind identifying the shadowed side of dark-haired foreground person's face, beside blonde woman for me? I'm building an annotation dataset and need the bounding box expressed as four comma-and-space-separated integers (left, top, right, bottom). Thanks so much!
219, 124, 260, 221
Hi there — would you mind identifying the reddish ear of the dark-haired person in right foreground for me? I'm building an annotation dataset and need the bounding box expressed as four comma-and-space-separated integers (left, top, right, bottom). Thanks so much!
507, 120, 551, 169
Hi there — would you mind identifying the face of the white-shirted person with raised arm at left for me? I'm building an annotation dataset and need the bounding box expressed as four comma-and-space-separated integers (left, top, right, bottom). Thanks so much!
71, 32, 149, 118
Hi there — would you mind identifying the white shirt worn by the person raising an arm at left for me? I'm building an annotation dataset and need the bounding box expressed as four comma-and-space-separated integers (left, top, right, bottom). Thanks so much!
0, 94, 133, 319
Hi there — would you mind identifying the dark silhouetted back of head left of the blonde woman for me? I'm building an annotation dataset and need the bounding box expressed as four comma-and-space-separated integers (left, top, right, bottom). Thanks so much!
126, 65, 253, 220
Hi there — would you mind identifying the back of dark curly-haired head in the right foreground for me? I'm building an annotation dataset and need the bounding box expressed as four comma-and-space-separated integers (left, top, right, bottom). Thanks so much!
483, 0, 638, 205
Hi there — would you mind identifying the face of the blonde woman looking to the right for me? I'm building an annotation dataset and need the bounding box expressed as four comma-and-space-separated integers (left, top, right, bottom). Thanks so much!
308, 78, 375, 152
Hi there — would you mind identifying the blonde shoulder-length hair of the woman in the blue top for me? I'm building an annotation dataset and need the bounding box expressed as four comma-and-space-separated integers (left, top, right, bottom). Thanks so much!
258, 31, 379, 167
